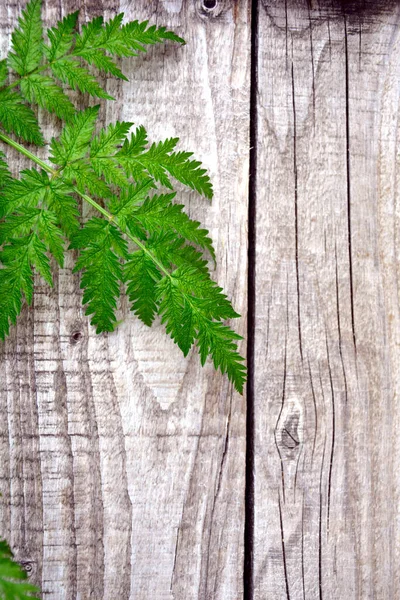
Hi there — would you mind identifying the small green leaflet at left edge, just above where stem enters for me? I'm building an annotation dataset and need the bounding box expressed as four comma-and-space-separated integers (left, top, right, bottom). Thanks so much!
0, 89, 44, 146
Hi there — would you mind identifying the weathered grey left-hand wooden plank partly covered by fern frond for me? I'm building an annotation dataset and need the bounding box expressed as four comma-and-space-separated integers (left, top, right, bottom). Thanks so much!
0, 0, 250, 600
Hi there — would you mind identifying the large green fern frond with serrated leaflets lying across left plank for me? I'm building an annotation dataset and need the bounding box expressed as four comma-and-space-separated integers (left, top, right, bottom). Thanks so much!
0, 0, 246, 392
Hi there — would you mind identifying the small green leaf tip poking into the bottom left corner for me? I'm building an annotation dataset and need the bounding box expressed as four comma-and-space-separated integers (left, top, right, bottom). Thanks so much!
0, 536, 39, 600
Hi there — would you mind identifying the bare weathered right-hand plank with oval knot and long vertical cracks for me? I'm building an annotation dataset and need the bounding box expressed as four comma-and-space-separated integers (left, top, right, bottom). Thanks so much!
254, 0, 400, 600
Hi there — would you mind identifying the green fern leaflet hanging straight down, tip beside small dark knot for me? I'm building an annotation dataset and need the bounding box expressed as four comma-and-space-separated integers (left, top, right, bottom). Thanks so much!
71, 218, 127, 333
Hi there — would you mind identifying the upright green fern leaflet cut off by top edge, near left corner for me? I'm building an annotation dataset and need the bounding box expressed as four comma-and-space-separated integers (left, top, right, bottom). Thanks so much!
8, 0, 43, 75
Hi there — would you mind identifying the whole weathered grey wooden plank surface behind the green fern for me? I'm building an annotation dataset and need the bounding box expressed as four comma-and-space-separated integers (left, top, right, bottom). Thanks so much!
0, 0, 400, 600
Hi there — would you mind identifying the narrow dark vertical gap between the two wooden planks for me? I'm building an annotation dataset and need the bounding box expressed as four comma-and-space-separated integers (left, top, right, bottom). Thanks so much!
243, 0, 258, 600
